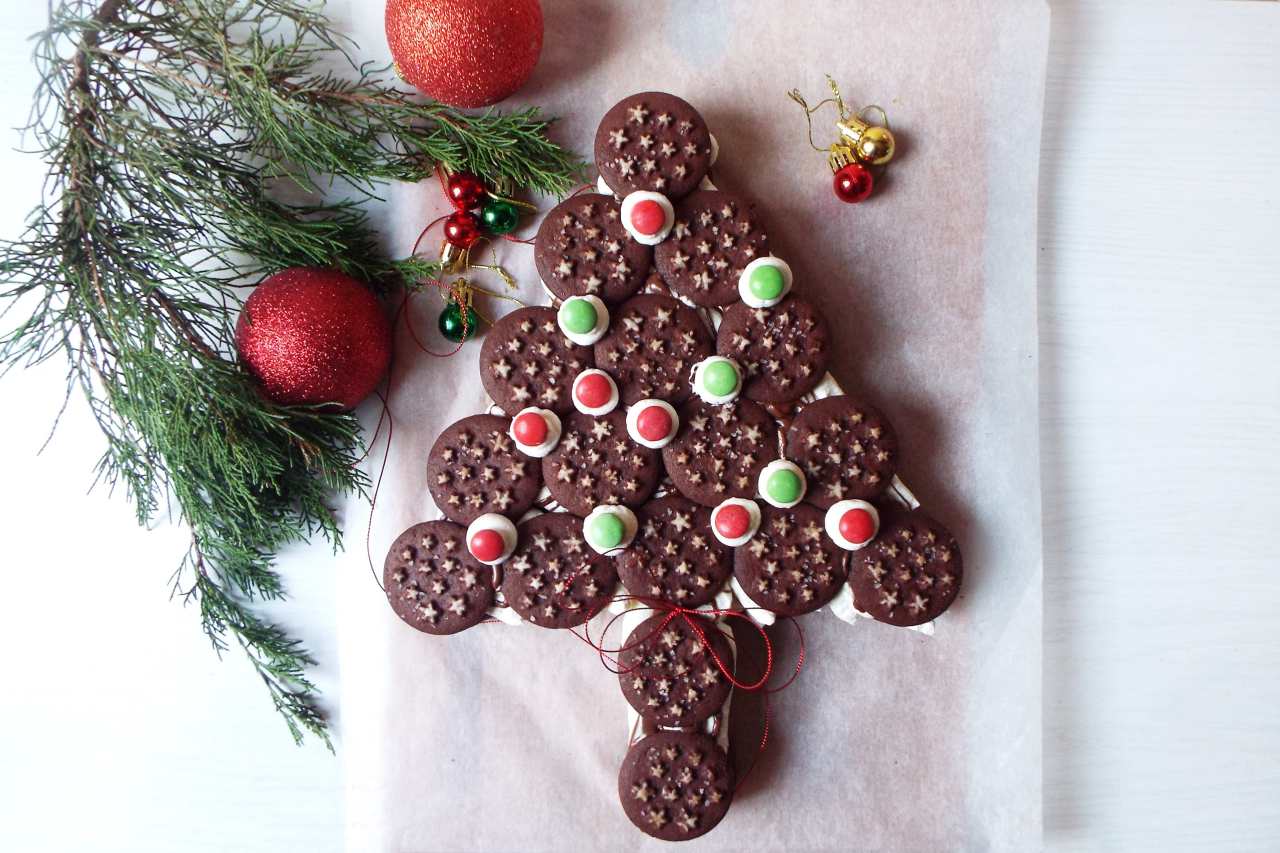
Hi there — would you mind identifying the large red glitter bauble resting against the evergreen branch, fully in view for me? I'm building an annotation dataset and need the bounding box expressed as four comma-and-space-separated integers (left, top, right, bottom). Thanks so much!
236, 266, 392, 409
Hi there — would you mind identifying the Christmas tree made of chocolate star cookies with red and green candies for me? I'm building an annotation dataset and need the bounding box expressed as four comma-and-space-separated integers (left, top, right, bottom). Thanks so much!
384, 92, 963, 840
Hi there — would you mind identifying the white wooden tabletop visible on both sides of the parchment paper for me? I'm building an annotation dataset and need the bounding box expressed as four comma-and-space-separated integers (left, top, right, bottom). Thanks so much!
0, 0, 1280, 850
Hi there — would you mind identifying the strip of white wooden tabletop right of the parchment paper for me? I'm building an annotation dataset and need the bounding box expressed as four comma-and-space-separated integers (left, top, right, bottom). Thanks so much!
1039, 3, 1280, 850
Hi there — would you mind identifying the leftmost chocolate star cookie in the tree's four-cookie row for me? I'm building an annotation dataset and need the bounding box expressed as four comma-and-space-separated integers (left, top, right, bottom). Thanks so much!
426, 415, 543, 524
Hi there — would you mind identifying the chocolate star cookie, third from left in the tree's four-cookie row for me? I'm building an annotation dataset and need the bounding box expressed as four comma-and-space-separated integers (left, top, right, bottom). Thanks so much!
662, 398, 778, 506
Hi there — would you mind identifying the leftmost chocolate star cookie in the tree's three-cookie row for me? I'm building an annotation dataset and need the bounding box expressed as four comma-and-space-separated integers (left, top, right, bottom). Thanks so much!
480, 307, 594, 415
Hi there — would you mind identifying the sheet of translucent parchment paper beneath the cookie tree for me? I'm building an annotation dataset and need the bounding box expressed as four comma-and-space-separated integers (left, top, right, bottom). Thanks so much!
338, 0, 1048, 850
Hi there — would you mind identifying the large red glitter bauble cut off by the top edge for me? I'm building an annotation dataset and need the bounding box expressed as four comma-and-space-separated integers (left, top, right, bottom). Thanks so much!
385, 0, 543, 106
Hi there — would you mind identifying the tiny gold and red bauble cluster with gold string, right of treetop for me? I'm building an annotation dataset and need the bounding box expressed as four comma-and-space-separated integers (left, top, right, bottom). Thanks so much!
787, 76, 896, 205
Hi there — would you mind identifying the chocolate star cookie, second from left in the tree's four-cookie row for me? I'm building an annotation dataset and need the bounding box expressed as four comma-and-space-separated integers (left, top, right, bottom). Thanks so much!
543, 409, 662, 515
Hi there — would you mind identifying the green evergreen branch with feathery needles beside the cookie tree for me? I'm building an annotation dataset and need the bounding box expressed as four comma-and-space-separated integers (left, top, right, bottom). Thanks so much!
0, 0, 580, 744
